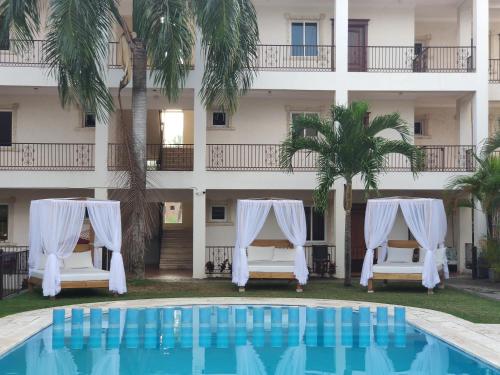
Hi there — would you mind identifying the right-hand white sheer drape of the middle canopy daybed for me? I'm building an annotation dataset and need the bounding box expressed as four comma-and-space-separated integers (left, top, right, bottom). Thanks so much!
273, 200, 309, 285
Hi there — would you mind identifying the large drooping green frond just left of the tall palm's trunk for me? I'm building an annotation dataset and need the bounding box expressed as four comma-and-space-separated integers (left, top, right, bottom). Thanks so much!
45, 0, 117, 119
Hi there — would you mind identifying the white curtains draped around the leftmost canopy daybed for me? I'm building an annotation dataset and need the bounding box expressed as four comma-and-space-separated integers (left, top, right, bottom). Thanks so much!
29, 199, 127, 296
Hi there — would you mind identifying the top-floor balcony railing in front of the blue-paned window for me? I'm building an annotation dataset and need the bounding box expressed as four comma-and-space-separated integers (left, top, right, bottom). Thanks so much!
255, 44, 335, 71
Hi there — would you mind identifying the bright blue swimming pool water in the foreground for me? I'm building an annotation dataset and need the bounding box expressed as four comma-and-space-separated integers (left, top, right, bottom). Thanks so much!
0, 306, 500, 375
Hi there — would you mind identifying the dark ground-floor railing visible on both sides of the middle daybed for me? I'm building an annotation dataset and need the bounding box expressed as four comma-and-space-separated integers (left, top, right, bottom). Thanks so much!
205, 245, 335, 276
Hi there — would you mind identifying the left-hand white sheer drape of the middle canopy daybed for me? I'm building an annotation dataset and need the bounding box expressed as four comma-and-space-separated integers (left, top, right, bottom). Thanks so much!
232, 199, 272, 286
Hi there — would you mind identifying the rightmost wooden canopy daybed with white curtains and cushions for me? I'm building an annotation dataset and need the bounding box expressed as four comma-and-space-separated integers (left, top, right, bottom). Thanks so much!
360, 197, 448, 293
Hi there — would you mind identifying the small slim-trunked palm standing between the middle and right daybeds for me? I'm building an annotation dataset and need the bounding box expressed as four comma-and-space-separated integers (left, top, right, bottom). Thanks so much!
280, 102, 421, 286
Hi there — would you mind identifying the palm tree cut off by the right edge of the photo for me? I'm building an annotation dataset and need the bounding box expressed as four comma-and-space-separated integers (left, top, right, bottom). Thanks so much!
446, 132, 500, 237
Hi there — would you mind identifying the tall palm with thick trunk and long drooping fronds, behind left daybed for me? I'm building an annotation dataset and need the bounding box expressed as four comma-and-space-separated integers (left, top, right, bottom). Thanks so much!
0, 0, 259, 278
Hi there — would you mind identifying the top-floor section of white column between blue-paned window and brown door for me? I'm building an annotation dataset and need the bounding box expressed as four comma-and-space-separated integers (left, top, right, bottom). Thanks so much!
334, 0, 349, 77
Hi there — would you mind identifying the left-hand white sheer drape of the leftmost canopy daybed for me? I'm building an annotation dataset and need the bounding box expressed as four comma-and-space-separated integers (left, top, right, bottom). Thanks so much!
30, 199, 85, 297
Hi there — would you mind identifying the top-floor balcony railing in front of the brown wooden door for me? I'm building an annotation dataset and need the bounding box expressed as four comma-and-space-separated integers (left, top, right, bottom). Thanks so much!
348, 46, 476, 73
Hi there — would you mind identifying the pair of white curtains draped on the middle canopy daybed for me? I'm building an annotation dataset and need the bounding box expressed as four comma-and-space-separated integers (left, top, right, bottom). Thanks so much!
232, 199, 309, 286
